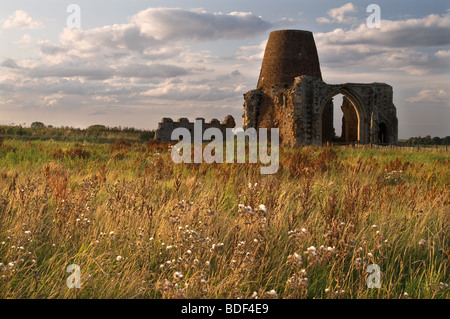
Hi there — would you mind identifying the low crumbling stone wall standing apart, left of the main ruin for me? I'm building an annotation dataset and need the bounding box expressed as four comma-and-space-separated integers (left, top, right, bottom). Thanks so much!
155, 115, 236, 142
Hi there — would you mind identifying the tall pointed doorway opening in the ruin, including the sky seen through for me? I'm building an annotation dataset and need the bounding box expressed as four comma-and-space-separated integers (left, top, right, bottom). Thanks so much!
319, 88, 362, 144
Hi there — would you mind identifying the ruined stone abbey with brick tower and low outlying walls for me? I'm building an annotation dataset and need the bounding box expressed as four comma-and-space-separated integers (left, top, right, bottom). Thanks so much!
155, 30, 398, 145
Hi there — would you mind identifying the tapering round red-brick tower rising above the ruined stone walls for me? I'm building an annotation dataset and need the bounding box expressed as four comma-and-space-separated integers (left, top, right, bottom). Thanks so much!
257, 30, 322, 92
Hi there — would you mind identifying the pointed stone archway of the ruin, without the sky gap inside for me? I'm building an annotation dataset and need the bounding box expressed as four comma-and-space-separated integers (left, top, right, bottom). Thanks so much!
316, 85, 369, 144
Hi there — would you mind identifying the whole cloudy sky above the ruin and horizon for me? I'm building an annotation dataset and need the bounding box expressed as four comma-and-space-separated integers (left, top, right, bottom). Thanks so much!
0, 0, 450, 139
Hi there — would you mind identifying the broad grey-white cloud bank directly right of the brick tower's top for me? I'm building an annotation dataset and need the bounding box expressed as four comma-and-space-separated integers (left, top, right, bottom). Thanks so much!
314, 14, 450, 75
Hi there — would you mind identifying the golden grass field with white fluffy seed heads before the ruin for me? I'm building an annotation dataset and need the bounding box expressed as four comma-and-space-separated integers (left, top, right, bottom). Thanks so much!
0, 140, 450, 299
